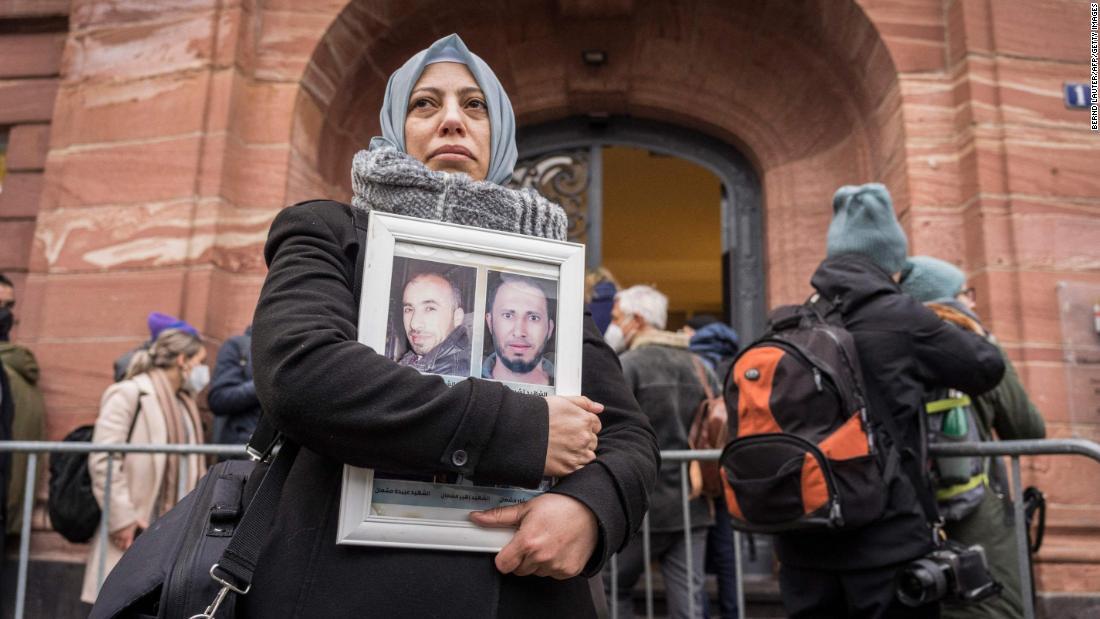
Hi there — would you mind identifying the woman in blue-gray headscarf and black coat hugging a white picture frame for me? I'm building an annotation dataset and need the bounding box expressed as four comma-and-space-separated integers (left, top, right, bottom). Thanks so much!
242, 35, 658, 618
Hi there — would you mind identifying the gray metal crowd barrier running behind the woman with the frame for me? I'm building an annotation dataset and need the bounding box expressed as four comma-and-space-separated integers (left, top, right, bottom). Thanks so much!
0, 439, 1100, 619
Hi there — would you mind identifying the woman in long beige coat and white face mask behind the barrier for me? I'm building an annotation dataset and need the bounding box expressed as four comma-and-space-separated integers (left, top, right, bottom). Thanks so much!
80, 329, 210, 604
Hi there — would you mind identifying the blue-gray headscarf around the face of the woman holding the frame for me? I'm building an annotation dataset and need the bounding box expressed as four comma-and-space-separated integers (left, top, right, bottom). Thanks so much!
371, 34, 517, 185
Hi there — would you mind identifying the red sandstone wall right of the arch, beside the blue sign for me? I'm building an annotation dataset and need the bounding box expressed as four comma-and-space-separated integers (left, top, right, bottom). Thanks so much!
865, 1, 1100, 592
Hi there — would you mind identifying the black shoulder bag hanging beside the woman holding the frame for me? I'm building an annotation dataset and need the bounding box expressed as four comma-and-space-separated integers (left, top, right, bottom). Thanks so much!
89, 418, 298, 619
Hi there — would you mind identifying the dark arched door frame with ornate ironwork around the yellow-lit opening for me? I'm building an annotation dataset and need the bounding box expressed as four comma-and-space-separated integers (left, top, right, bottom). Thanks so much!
516, 117, 766, 336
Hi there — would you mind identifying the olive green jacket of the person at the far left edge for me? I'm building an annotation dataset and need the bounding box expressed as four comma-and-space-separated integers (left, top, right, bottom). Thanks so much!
0, 342, 46, 533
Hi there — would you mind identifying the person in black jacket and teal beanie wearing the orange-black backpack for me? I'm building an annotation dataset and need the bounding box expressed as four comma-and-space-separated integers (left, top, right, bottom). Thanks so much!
777, 184, 1004, 619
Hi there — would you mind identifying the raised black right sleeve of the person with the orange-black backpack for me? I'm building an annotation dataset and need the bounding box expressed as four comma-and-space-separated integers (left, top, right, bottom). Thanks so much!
894, 295, 1004, 396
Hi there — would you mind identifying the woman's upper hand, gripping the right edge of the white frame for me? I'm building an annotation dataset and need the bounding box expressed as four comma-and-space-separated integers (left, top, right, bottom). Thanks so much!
543, 396, 604, 477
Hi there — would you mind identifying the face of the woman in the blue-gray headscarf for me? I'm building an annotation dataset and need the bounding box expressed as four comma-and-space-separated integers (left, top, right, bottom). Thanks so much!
405, 63, 491, 180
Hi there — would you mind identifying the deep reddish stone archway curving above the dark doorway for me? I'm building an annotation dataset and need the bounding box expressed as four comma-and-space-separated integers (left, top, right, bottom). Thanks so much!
286, 0, 909, 305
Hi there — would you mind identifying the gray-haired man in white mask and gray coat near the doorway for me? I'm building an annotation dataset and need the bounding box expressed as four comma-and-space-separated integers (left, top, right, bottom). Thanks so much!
604, 286, 717, 618
